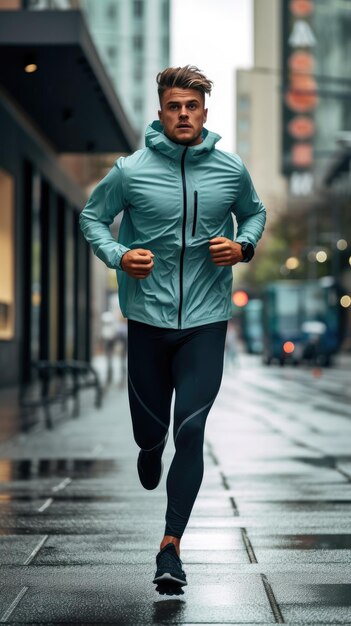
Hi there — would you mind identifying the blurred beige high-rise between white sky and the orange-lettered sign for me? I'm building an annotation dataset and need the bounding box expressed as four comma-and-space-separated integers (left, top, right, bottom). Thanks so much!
236, 0, 287, 217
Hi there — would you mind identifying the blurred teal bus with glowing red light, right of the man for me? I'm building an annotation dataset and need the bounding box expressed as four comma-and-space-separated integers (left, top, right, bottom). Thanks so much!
263, 277, 342, 366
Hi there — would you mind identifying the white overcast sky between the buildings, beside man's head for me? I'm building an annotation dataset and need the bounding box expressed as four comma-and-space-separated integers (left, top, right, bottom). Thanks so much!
171, 0, 252, 152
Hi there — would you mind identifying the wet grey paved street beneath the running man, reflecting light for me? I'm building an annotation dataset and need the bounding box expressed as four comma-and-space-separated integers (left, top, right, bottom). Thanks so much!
0, 355, 351, 626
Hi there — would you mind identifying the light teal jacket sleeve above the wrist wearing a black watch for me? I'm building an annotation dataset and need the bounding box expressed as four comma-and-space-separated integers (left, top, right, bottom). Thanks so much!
233, 163, 266, 246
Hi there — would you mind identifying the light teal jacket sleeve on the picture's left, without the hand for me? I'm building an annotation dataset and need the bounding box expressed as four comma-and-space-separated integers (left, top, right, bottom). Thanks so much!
79, 158, 129, 269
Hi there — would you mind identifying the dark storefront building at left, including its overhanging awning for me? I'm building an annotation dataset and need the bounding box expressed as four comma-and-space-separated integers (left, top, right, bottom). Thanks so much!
0, 10, 136, 387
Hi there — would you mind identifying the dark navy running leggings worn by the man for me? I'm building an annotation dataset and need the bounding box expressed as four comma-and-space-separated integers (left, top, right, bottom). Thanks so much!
128, 320, 227, 537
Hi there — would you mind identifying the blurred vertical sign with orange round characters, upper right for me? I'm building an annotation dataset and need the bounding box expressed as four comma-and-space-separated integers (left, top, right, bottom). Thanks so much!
282, 0, 318, 196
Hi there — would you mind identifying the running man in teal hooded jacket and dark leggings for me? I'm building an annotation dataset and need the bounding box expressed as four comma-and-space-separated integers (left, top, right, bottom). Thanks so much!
80, 65, 266, 589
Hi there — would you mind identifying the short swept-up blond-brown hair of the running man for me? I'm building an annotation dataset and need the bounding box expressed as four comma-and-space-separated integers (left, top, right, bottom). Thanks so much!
156, 65, 213, 104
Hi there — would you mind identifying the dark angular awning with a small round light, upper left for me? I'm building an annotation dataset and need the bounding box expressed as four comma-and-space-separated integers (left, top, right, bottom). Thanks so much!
0, 11, 137, 153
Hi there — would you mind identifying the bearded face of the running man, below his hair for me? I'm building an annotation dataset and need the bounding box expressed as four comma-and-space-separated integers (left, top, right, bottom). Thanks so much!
158, 87, 207, 146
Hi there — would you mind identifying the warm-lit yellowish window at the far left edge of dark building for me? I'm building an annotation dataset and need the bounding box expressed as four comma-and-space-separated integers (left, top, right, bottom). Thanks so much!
0, 169, 15, 339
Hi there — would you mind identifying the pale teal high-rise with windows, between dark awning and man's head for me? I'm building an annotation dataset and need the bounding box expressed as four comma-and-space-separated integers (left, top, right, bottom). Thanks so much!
80, 0, 170, 138
